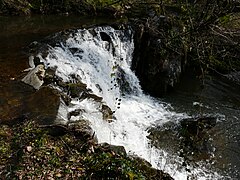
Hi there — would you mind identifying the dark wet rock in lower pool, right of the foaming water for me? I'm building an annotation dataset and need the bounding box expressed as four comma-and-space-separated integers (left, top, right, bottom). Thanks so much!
148, 117, 216, 166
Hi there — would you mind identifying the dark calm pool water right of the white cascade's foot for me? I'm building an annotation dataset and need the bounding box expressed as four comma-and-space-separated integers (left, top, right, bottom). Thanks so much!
163, 71, 240, 179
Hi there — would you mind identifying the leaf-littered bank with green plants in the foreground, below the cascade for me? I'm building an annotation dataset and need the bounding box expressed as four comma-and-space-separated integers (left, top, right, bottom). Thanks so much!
0, 121, 170, 179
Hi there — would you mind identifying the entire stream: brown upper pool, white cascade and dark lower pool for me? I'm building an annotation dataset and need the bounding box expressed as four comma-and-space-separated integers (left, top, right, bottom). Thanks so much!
0, 16, 240, 180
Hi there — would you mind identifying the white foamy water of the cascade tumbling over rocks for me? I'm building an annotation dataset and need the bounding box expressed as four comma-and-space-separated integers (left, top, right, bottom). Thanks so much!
38, 26, 220, 180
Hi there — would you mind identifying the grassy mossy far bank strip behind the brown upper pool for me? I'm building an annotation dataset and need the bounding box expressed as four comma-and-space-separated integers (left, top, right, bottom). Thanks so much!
0, 0, 129, 16
